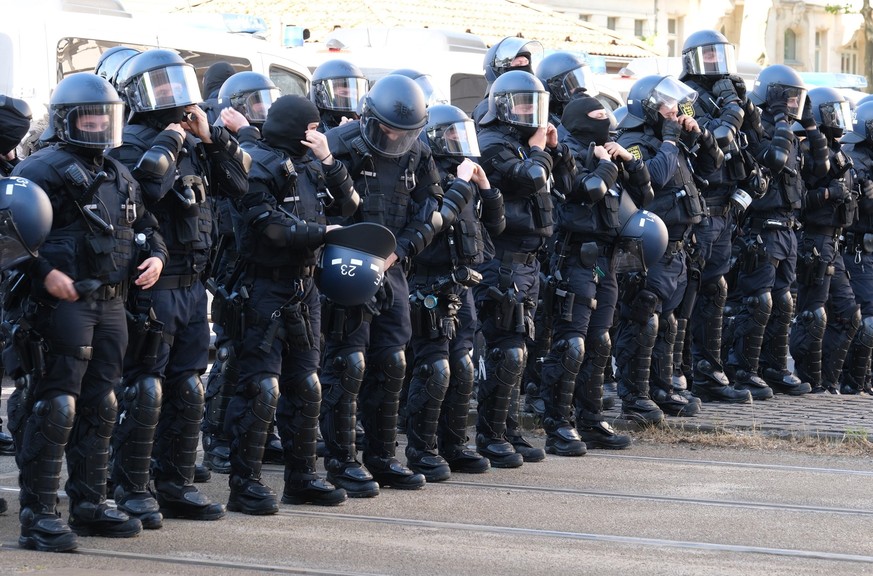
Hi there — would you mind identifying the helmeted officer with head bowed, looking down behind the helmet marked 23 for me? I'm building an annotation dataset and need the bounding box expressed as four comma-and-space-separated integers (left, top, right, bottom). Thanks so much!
321, 74, 442, 497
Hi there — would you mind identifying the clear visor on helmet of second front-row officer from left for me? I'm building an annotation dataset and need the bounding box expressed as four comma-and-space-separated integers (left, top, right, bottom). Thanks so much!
127, 65, 203, 112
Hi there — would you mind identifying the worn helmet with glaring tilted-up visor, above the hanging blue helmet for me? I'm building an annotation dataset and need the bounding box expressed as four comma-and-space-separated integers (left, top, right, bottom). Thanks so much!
618, 76, 697, 128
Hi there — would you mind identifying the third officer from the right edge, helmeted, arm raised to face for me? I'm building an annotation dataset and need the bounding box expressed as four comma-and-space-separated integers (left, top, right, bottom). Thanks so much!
725, 64, 829, 400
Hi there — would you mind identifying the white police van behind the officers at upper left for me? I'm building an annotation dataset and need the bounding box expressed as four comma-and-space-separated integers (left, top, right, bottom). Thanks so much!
0, 0, 312, 119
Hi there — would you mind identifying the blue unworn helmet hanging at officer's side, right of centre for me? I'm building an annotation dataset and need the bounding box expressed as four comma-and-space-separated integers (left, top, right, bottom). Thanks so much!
613, 197, 668, 273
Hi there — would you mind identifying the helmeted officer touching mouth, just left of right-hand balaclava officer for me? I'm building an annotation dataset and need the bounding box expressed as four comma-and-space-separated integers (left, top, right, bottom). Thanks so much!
474, 70, 574, 468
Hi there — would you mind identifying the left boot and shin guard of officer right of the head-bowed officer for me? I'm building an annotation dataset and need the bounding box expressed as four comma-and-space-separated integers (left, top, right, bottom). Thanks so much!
406, 358, 452, 482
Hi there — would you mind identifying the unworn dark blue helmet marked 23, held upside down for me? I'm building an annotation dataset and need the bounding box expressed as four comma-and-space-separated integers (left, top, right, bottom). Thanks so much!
315, 222, 397, 306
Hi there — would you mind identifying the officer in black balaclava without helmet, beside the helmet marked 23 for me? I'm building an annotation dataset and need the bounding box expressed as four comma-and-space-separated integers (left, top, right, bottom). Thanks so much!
225, 95, 359, 514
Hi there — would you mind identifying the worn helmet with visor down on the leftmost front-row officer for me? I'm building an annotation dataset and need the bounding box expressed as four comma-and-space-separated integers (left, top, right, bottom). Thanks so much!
40, 72, 124, 149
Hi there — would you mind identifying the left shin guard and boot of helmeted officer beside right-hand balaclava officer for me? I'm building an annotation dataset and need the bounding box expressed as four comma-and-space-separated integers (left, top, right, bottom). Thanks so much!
476, 348, 524, 468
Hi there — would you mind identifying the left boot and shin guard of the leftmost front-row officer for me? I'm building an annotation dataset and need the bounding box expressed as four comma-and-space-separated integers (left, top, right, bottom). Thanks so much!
17, 396, 78, 552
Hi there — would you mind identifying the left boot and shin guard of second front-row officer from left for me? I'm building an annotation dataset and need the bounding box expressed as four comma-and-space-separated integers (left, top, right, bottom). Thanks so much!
111, 376, 163, 530
